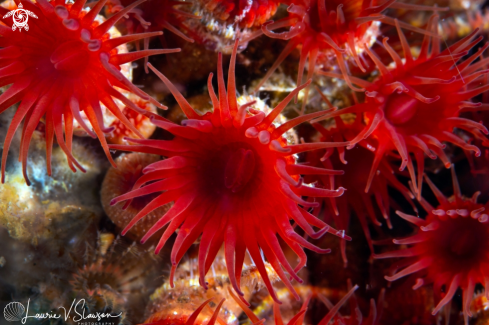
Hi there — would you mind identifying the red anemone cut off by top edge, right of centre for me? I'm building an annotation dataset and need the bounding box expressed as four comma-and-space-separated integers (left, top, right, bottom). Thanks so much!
248, 0, 442, 109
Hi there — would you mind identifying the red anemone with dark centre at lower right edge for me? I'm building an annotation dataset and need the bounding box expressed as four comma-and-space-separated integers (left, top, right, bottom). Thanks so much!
376, 166, 489, 324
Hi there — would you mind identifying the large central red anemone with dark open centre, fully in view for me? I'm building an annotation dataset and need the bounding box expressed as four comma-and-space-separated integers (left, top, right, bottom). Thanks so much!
111, 42, 348, 300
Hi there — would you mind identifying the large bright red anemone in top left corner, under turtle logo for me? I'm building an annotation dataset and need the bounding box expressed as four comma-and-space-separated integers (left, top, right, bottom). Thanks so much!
0, 0, 179, 184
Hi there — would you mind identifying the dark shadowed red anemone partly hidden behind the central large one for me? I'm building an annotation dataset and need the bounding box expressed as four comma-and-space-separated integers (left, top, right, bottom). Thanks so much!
305, 117, 414, 264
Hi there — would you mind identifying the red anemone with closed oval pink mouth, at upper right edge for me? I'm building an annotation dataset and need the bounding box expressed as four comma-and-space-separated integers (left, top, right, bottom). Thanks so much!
314, 15, 489, 198
